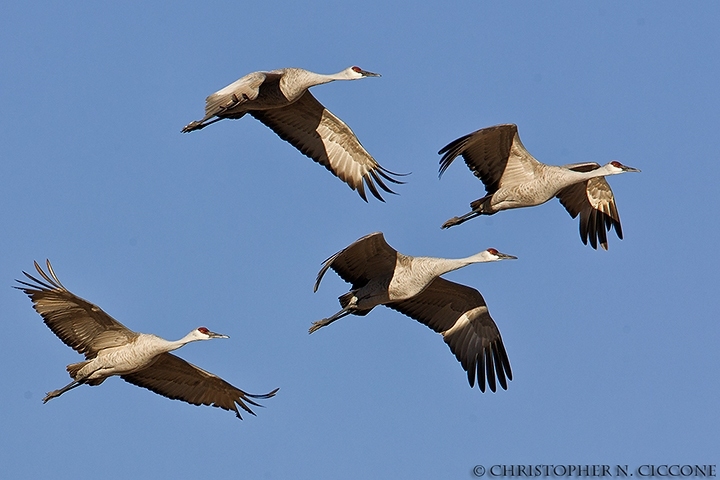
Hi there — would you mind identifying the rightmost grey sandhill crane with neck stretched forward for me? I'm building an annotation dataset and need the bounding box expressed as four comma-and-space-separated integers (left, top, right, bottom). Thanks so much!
438, 124, 640, 250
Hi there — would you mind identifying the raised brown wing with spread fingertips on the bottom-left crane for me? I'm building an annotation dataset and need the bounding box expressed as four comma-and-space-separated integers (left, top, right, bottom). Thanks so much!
15, 260, 138, 359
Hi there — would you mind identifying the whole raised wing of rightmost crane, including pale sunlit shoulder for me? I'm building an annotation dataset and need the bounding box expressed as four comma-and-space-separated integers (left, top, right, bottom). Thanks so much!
438, 124, 538, 195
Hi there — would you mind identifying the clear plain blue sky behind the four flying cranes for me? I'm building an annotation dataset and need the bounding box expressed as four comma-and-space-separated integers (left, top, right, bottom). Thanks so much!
0, 1, 720, 479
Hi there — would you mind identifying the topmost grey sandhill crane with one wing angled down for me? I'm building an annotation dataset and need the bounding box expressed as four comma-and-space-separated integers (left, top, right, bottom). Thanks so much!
182, 67, 404, 202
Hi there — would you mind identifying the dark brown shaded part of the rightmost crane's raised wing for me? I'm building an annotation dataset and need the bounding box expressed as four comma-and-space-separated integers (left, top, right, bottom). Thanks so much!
438, 124, 529, 194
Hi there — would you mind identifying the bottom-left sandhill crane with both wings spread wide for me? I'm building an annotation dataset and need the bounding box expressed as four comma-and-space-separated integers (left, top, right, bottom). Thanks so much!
15, 260, 278, 419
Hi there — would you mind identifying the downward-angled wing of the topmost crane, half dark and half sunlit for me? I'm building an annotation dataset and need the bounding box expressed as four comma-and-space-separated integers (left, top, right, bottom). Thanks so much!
249, 92, 403, 201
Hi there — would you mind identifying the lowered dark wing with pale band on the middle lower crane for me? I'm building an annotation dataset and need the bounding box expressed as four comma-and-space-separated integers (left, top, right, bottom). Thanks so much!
386, 277, 512, 392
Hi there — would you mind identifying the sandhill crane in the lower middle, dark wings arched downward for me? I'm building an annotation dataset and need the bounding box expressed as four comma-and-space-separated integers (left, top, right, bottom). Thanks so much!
310, 232, 516, 392
